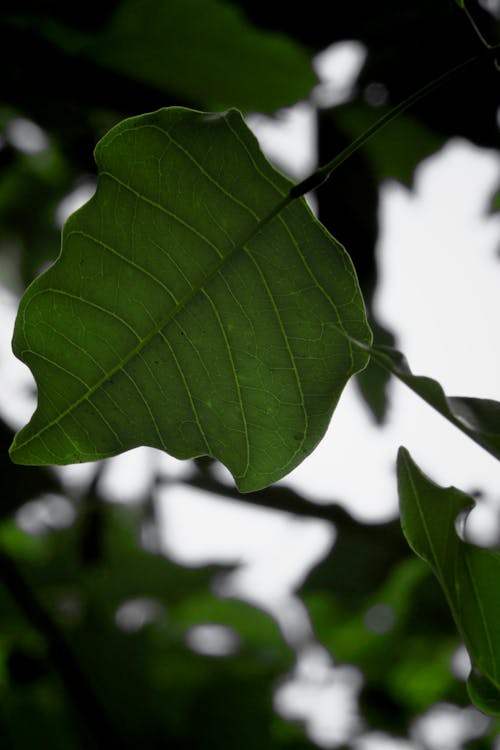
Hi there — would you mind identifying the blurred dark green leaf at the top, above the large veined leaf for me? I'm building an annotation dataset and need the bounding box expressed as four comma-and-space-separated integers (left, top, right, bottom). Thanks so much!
42, 0, 316, 112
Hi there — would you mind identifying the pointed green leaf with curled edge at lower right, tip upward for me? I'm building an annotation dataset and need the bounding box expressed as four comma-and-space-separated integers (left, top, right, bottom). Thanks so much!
398, 448, 500, 715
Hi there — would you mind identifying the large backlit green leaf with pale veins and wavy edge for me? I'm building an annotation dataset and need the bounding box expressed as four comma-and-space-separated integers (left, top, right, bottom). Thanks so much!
7, 107, 371, 491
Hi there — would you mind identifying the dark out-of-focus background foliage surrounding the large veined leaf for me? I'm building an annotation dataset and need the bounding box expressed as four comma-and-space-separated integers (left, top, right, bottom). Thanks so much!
0, 0, 500, 750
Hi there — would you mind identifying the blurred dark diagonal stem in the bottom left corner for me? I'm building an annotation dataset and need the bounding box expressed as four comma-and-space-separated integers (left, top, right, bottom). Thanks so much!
0, 550, 127, 750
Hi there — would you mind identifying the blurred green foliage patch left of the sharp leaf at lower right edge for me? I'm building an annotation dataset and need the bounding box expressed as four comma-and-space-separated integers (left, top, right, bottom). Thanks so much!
301, 502, 468, 733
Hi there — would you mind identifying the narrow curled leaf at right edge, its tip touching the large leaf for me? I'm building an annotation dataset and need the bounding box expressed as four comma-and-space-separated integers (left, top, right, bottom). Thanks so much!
369, 346, 500, 459
